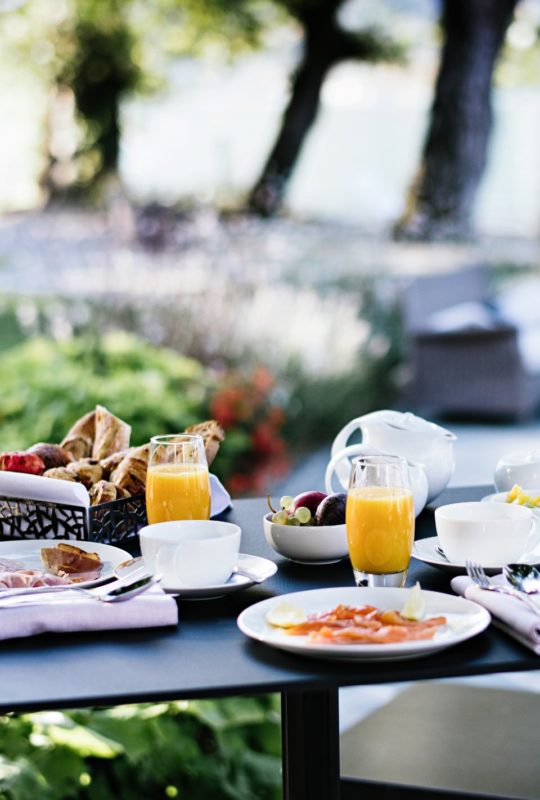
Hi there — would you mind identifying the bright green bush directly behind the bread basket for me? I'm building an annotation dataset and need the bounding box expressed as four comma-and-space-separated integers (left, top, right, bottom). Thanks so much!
0, 333, 212, 450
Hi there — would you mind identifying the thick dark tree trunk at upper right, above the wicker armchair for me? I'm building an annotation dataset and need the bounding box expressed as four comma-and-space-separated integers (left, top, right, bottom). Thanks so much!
395, 0, 518, 240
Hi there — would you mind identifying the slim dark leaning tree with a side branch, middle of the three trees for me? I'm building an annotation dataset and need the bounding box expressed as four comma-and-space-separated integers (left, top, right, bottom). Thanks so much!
248, 0, 404, 216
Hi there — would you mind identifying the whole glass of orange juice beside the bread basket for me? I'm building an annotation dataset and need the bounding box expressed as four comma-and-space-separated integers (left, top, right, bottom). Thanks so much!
146, 433, 210, 524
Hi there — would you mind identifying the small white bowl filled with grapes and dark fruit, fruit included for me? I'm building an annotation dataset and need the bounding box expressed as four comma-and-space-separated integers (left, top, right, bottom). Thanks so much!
263, 492, 348, 564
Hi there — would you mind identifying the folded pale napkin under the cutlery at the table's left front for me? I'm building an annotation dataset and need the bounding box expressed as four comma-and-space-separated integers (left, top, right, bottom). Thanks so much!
0, 586, 178, 640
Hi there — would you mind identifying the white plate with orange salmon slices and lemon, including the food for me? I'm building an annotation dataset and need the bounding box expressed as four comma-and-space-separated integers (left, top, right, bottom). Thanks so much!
238, 587, 491, 661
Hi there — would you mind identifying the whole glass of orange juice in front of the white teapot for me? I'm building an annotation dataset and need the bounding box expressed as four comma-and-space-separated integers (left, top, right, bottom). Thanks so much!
346, 455, 414, 586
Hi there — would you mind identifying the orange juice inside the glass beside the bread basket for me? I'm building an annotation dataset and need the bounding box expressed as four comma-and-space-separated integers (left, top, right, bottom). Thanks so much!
146, 464, 210, 524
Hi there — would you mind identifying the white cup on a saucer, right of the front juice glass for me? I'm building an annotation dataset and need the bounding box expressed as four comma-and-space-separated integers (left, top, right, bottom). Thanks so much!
435, 502, 538, 567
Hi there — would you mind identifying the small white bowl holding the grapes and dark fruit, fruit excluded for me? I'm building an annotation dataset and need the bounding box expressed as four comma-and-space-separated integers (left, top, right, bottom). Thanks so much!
263, 513, 349, 564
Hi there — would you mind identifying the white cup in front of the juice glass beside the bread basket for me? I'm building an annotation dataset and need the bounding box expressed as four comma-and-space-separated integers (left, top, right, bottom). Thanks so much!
139, 520, 241, 588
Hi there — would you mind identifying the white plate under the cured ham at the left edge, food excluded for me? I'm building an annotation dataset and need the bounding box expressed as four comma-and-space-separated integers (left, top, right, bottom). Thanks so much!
0, 539, 129, 586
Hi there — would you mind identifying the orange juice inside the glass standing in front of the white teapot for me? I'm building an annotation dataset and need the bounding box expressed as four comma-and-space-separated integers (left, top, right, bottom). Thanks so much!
346, 486, 414, 575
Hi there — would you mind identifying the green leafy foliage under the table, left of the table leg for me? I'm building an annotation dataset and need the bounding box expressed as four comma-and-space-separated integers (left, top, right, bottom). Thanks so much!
0, 695, 281, 800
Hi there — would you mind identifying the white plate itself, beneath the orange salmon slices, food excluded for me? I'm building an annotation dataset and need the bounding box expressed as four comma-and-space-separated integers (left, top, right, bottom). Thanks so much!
238, 587, 491, 661
